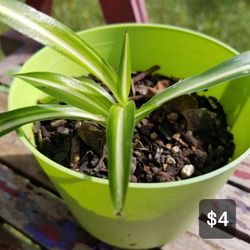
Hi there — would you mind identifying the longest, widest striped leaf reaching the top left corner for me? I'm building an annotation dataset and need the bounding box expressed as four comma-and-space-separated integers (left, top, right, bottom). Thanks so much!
0, 0, 117, 95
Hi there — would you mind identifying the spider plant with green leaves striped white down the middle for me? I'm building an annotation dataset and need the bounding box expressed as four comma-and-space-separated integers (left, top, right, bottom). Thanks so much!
0, 0, 250, 215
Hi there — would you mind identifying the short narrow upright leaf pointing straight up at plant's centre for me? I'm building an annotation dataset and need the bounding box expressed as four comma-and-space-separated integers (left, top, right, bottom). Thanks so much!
117, 31, 131, 104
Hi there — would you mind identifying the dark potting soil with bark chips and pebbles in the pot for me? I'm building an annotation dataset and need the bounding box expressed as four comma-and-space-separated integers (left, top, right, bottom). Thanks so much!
34, 66, 235, 182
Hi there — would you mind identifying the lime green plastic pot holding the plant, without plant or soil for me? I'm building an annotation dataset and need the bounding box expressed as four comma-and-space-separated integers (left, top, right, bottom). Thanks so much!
9, 24, 250, 249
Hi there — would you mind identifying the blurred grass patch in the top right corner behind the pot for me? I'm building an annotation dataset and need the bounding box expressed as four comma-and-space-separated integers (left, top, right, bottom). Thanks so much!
146, 0, 250, 51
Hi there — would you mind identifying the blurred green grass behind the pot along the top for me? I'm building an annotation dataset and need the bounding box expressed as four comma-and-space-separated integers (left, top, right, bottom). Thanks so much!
0, 0, 250, 51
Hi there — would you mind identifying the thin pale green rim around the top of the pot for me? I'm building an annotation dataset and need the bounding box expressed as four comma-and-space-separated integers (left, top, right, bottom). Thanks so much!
9, 23, 250, 189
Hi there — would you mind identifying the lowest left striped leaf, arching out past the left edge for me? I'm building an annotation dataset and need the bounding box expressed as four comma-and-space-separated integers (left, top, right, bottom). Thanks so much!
0, 105, 106, 136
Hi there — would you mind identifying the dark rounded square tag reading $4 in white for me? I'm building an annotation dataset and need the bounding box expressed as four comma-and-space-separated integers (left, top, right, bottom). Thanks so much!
199, 199, 236, 239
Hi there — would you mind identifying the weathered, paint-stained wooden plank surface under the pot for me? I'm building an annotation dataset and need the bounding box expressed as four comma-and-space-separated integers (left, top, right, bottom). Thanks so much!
0, 54, 250, 250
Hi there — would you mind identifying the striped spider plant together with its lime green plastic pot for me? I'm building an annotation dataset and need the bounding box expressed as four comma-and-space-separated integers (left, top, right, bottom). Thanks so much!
0, 0, 250, 249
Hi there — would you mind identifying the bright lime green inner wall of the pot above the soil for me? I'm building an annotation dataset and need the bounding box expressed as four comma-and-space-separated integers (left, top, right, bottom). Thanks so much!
9, 24, 250, 164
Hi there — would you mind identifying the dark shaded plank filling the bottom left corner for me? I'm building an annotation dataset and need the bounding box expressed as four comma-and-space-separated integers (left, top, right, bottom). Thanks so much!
0, 225, 41, 250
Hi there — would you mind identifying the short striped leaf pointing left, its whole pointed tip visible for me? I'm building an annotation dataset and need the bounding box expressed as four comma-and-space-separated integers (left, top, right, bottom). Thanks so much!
16, 72, 113, 116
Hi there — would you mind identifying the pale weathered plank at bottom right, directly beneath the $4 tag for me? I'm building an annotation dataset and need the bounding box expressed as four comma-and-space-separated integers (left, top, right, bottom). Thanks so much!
162, 221, 249, 250
